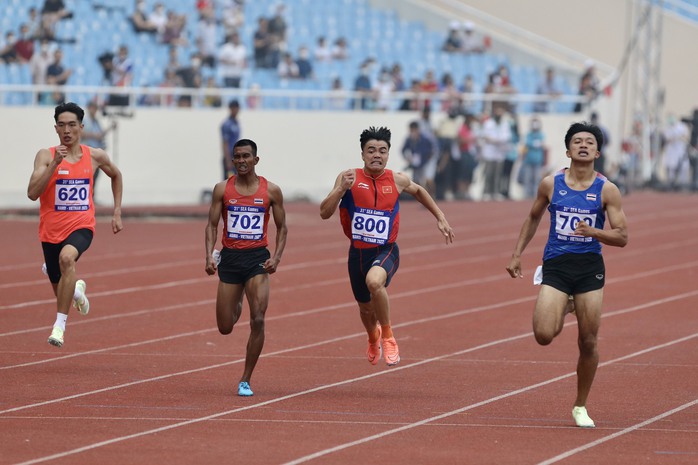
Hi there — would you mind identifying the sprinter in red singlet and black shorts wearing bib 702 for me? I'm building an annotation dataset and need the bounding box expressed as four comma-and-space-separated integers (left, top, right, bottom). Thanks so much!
206, 139, 287, 397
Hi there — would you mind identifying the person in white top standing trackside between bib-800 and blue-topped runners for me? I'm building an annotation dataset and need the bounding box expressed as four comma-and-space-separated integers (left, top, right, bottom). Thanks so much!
480, 104, 511, 200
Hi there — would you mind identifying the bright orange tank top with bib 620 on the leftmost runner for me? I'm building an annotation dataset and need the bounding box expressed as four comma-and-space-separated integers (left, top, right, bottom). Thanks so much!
39, 145, 95, 244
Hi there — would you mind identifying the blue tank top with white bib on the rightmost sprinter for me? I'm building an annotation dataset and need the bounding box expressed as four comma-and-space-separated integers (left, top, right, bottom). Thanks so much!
543, 169, 606, 261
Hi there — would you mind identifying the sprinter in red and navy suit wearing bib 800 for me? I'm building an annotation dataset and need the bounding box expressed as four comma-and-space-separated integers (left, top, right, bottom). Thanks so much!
320, 127, 455, 366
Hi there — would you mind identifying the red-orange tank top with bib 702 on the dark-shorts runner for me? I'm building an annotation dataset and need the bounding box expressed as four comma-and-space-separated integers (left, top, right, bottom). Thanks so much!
221, 176, 269, 250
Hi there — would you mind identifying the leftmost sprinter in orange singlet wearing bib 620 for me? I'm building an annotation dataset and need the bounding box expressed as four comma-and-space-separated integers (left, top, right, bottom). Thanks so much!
27, 102, 123, 347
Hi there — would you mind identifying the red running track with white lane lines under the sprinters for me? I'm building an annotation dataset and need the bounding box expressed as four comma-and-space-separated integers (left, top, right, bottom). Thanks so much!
0, 193, 698, 465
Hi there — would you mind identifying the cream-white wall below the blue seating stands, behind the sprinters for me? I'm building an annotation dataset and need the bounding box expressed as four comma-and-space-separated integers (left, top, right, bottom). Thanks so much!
0, 107, 583, 208
